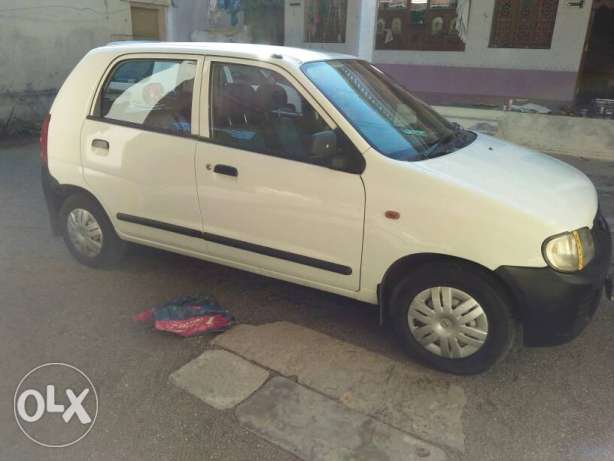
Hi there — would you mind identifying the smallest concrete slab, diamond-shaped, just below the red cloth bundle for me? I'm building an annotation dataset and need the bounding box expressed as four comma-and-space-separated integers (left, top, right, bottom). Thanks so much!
170, 350, 269, 410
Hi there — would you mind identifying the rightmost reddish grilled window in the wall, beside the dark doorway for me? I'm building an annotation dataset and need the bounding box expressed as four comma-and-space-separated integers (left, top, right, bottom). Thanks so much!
490, 0, 559, 49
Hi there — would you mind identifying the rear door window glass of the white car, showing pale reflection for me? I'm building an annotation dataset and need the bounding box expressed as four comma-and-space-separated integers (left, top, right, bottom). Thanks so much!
96, 59, 196, 135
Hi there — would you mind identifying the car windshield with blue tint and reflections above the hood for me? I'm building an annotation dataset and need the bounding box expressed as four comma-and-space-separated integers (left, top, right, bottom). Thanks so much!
301, 60, 458, 161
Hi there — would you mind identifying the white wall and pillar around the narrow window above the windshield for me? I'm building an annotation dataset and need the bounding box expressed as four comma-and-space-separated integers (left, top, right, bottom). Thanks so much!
285, 0, 377, 60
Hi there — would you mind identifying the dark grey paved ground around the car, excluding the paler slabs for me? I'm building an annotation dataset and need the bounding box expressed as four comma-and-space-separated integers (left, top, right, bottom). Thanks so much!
0, 140, 614, 461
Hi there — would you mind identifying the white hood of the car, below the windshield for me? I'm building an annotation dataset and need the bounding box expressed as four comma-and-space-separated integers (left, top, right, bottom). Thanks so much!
416, 134, 598, 232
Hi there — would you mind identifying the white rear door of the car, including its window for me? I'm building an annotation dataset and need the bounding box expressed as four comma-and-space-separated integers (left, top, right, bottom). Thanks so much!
81, 54, 206, 252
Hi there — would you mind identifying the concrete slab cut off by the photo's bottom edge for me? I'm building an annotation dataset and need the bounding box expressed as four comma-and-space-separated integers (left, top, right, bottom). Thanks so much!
235, 377, 446, 461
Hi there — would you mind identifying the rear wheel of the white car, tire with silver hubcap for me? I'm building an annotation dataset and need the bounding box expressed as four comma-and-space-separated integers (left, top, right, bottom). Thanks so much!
59, 194, 126, 268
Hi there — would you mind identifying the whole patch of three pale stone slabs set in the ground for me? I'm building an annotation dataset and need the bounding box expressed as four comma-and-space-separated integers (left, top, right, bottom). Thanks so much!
170, 322, 454, 461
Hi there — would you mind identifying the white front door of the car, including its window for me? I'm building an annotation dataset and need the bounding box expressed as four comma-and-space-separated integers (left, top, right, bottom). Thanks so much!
196, 58, 365, 290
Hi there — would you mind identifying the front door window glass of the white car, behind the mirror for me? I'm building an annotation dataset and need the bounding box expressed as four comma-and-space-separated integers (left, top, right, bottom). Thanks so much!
210, 62, 360, 169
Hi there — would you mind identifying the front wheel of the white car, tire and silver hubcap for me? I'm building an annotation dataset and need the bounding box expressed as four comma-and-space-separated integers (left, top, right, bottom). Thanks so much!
390, 262, 517, 375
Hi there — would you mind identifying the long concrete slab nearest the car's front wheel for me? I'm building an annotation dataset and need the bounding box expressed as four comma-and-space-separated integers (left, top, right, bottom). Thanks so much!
214, 322, 466, 451
